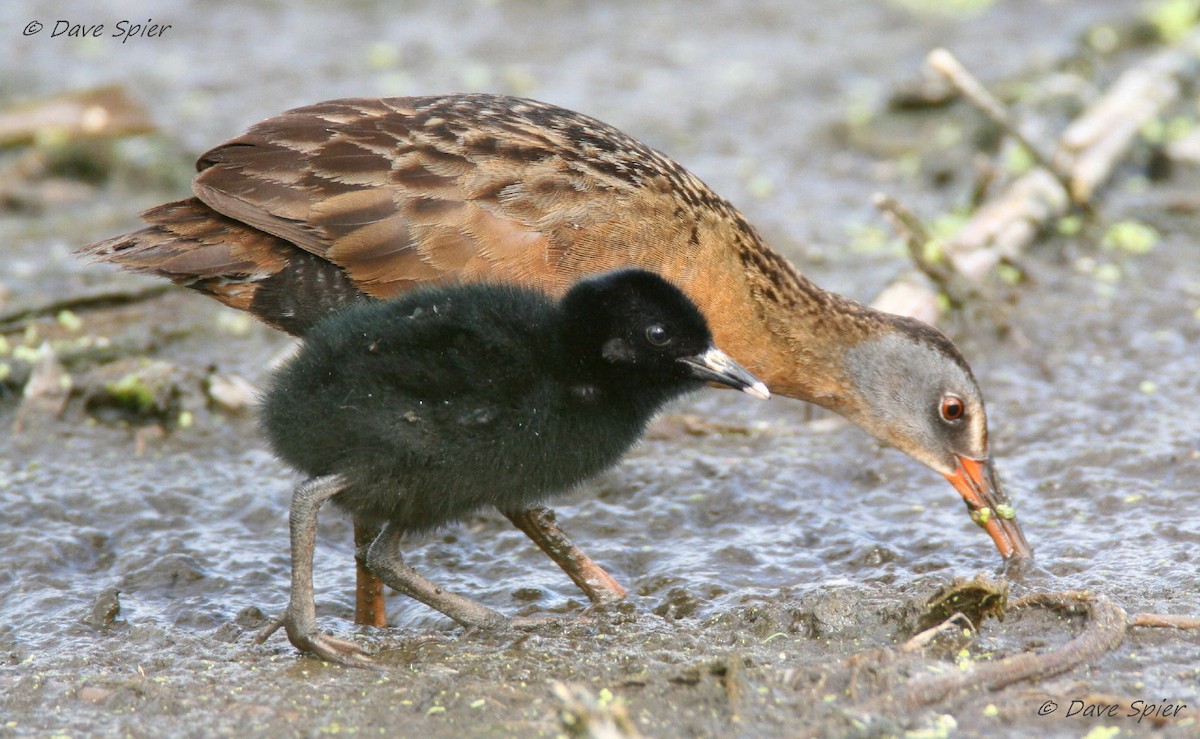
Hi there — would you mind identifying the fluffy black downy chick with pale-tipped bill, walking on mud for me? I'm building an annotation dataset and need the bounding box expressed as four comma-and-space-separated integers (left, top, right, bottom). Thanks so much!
262, 269, 769, 665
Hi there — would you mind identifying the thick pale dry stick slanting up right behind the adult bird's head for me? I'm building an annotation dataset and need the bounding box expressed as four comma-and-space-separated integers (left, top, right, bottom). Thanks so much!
872, 31, 1200, 323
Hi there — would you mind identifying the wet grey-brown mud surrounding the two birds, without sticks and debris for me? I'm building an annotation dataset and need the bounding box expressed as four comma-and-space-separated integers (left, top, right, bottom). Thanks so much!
0, 0, 1200, 737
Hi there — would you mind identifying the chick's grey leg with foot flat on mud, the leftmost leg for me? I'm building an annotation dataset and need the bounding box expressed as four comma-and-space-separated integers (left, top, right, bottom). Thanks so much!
272, 475, 374, 667
